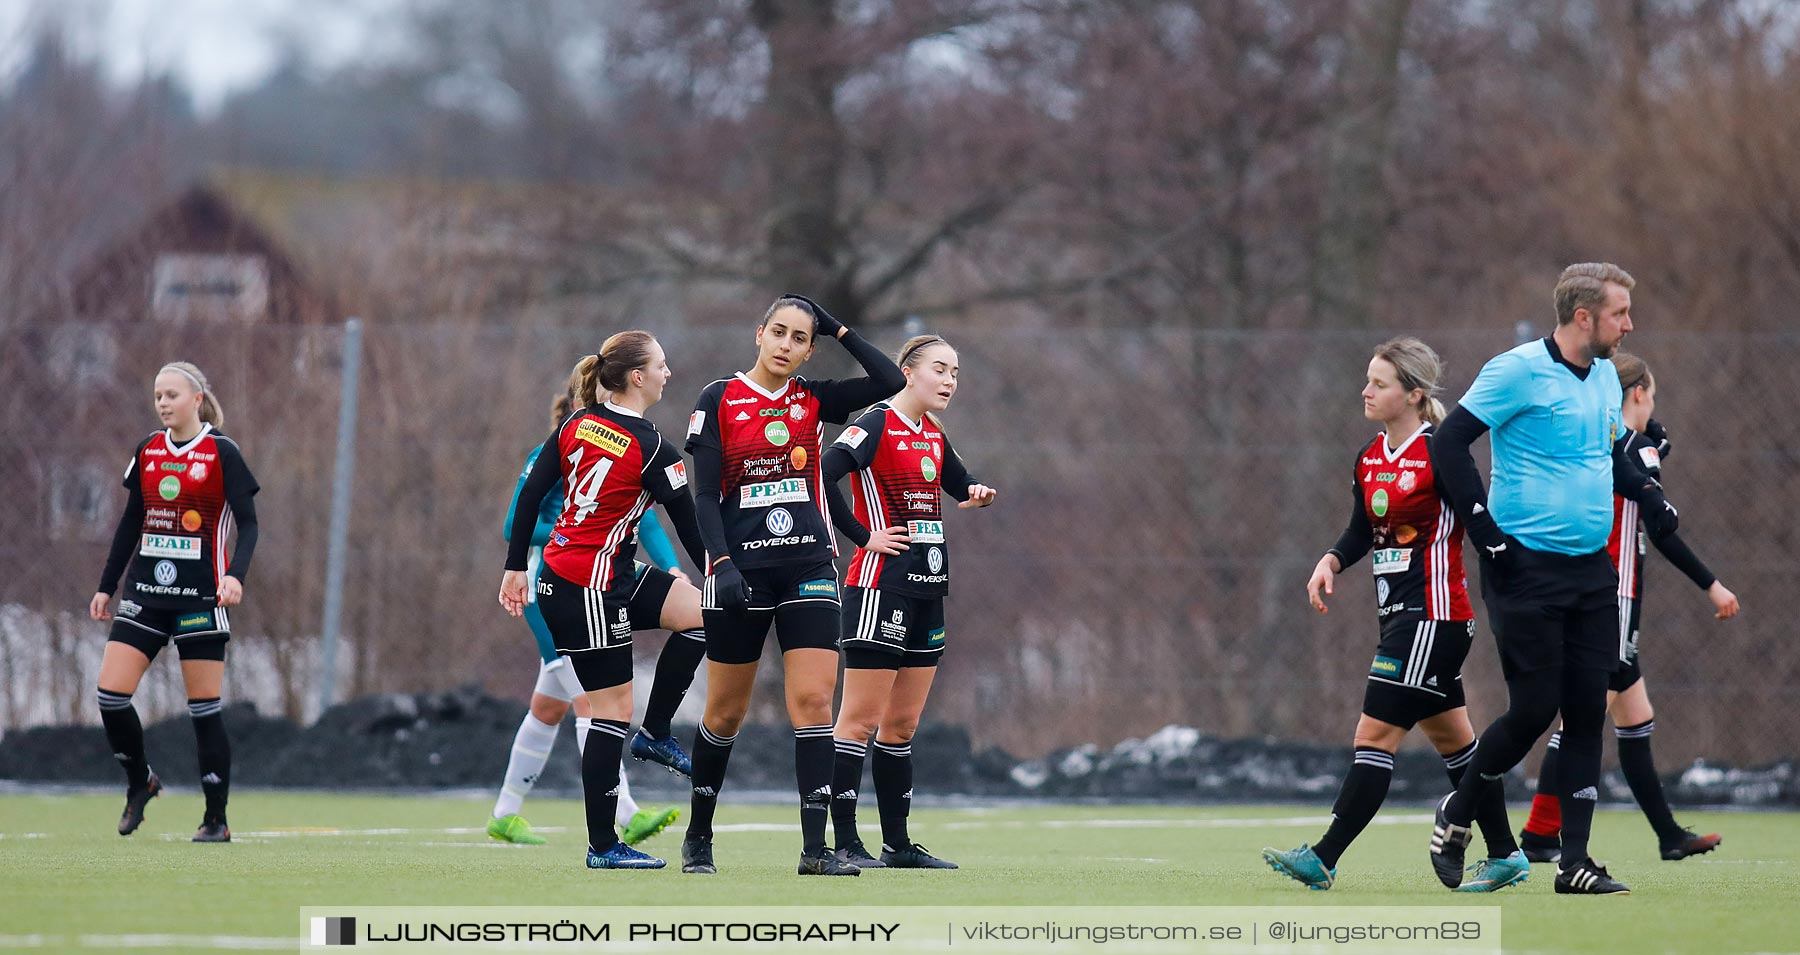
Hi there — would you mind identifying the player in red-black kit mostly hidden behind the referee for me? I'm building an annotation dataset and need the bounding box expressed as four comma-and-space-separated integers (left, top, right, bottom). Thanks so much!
1519, 353, 1739, 861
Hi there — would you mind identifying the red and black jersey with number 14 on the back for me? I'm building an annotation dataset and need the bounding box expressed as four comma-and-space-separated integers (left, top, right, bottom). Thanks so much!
520, 403, 691, 590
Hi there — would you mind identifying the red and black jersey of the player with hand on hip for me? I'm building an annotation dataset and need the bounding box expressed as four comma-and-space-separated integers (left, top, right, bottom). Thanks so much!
826, 403, 972, 597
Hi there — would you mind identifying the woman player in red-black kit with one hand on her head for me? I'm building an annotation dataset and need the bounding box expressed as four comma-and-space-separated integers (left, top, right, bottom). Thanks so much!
680, 295, 905, 876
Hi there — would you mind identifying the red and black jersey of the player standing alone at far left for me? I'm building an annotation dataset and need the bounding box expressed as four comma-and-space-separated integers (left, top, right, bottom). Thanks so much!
101, 424, 259, 608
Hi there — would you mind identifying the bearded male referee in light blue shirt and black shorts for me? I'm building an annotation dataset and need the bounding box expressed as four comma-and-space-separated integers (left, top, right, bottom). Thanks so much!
1431, 263, 1676, 896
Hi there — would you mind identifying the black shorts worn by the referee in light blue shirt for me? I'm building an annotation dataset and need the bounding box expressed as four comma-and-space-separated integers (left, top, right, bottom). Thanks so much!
1481, 547, 1620, 680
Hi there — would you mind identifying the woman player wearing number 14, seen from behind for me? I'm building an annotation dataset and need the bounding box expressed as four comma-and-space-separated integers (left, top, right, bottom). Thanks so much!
500, 331, 706, 869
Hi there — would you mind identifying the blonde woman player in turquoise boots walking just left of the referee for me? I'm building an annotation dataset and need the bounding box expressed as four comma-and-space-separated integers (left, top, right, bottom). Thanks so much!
1262, 338, 1530, 892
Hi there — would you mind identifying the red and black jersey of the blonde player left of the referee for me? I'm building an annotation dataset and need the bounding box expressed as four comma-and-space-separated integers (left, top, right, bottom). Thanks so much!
1334, 424, 1474, 620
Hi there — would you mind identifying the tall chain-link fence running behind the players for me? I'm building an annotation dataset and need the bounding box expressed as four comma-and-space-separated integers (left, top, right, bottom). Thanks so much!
0, 322, 1800, 764
